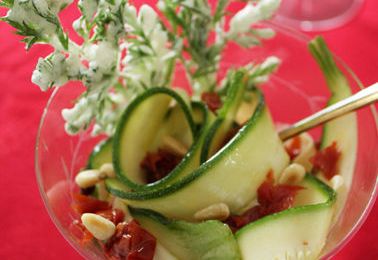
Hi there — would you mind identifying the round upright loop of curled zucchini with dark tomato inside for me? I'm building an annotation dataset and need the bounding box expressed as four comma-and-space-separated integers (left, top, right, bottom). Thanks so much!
113, 88, 195, 190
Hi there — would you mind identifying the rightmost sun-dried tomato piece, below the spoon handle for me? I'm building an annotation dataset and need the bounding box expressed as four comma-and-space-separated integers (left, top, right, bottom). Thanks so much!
310, 142, 341, 180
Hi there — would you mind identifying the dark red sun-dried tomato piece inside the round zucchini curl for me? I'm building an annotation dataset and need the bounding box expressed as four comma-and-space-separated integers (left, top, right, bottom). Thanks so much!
140, 149, 182, 183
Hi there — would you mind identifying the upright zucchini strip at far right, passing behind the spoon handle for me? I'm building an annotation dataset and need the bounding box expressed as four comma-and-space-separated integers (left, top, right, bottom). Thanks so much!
309, 37, 358, 220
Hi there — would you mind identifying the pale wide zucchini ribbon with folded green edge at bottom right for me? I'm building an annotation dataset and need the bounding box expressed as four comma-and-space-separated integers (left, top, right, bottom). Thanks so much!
235, 174, 336, 260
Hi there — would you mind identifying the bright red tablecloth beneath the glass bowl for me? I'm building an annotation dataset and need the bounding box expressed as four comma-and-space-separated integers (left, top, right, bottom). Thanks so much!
0, 0, 378, 260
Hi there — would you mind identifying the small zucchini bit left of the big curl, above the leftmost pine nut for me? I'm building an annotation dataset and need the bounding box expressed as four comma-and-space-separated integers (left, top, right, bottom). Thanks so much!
87, 137, 113, 169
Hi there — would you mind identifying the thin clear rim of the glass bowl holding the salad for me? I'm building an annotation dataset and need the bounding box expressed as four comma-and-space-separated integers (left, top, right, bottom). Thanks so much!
34, 21, 378, 259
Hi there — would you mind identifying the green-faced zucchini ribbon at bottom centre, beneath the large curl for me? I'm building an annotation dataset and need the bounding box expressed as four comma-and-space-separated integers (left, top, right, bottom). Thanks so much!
130, 208, 241, 260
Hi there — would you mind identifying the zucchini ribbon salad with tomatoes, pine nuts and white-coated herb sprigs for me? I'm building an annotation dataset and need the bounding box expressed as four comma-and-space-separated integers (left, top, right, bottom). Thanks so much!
1, 0, 370, 259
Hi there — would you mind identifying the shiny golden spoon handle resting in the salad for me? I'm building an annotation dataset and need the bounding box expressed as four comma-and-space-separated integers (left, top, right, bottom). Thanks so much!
278, 82, 378, 140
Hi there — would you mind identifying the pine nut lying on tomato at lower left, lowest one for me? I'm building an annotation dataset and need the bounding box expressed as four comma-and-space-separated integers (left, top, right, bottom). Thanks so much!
81, 213, 115, 240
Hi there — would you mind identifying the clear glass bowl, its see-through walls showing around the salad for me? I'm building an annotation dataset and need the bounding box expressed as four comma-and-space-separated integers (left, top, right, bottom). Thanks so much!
35, 23, 378, 259
